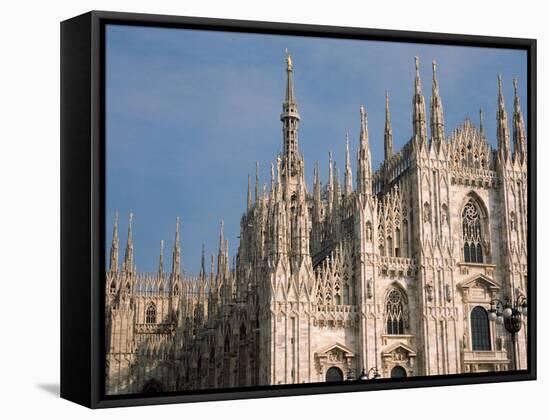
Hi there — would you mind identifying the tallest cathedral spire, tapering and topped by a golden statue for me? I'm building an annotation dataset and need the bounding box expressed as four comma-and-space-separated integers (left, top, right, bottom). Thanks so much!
281, 50, 300, 178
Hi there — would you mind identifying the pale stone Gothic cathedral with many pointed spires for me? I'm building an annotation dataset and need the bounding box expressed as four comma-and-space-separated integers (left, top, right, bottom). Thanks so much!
105, 50, 528, 395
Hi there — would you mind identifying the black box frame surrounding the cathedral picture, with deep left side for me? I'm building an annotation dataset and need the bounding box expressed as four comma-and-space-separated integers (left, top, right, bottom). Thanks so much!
61, 11, 537, 408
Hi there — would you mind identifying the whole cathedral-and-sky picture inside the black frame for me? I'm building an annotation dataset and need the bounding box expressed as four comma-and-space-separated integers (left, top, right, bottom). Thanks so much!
104, 24, 529, 395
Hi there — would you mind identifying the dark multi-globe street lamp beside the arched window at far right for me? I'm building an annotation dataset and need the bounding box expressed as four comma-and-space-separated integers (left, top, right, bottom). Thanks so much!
489, 293, 527, 370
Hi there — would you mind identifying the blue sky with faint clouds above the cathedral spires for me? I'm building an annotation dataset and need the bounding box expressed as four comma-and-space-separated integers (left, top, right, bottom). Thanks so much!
106, 25, 527, 274
